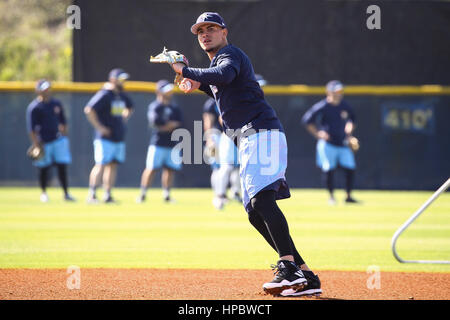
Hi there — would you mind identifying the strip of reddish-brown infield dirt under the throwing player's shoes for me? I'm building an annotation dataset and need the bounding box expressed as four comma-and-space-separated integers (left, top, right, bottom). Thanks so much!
0, 269, 450, 300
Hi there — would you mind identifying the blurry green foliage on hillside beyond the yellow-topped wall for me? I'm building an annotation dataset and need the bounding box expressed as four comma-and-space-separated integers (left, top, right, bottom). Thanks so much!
0, 0, 72, 81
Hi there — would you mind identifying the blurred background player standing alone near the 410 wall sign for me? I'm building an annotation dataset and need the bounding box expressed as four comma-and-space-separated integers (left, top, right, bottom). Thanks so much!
302, 80, 357, 205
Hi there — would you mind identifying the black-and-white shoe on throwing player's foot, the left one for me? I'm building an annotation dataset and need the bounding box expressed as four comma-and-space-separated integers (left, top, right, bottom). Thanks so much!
263, 260, 307, 296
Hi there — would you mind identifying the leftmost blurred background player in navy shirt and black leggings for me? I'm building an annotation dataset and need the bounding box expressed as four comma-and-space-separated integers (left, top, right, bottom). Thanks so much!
26, 79, 75, 202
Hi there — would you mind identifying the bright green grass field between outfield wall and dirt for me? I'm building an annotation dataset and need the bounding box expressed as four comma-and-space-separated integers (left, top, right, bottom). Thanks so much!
0, 187, 450, 273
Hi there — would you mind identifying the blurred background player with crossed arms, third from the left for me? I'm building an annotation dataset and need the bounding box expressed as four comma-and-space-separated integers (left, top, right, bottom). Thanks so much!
137, 80, 183, 203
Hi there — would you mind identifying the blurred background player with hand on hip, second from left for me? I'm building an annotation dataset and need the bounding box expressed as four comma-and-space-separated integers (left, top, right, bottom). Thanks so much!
84, 68, 133, 203
